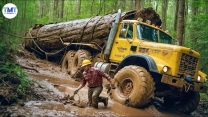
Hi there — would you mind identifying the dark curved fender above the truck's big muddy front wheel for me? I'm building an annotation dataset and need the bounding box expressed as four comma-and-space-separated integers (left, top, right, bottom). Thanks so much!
115, 54, 158, 73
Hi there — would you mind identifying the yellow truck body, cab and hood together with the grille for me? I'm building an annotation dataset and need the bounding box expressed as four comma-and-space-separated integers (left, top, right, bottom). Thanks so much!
109, 20, 206, 86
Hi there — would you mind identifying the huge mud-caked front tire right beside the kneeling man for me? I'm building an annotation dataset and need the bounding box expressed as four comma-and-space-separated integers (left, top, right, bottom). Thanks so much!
111, 65, 155, 107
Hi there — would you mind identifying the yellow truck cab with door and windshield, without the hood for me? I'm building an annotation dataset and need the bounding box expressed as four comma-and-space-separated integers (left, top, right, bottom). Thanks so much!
110, 20, 173, 62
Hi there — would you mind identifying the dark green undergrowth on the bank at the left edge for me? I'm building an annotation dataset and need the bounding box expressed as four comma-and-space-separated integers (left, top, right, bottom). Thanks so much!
0, 35, 31, 105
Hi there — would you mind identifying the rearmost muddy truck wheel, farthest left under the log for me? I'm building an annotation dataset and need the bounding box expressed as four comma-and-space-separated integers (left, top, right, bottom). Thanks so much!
61, 50, 76, 74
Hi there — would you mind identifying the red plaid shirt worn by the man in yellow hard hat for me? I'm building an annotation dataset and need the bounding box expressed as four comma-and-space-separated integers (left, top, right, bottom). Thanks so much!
82, 67, 110, 87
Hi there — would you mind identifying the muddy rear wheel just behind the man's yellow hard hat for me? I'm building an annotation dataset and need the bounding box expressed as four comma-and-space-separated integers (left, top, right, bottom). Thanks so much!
70, 49, 91, 78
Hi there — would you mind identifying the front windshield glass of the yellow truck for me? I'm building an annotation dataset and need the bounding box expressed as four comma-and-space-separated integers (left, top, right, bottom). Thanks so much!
137, 24, 172, 44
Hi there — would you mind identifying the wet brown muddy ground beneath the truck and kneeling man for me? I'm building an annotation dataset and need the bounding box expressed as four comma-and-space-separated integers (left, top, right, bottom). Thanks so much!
1, 50, 208, 117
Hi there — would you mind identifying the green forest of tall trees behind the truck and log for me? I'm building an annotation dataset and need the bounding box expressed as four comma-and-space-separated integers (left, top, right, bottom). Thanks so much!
0, 0, 208, 106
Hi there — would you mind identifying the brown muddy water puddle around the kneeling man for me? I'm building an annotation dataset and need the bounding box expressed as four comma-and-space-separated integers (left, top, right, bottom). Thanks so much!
26, 74, 192, 117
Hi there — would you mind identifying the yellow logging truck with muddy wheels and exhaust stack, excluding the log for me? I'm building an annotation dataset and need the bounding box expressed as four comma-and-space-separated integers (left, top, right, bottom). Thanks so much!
25, 10, 207, 113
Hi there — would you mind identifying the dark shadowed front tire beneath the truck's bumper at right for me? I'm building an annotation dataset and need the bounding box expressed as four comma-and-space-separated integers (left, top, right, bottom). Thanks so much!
164, 91, 200, 114
